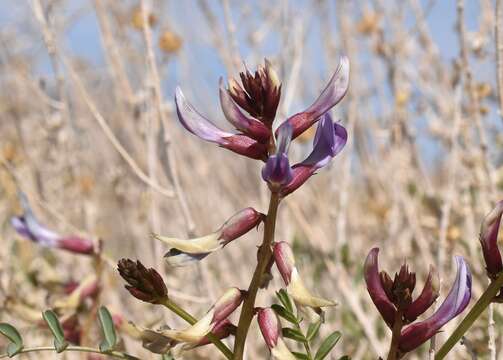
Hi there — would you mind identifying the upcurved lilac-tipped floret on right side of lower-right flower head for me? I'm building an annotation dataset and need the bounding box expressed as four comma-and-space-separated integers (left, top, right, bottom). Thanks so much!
400, 256, 472, 352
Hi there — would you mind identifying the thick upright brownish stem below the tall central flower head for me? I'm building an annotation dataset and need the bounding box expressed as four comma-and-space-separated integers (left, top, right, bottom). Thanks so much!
233, 192, 280, 360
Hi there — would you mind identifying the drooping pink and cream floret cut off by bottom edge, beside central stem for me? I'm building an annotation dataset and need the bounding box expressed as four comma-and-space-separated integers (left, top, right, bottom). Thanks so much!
257, 308, 296, 360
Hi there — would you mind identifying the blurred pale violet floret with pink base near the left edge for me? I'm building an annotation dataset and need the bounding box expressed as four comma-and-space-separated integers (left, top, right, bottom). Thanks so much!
11, 193, 94, 255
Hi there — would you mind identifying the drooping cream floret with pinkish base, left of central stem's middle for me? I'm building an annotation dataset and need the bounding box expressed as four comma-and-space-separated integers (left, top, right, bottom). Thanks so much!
153, 207, 265, 266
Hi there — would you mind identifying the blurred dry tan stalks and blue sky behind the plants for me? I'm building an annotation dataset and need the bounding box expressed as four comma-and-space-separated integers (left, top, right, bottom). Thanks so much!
0, 0, 503, 360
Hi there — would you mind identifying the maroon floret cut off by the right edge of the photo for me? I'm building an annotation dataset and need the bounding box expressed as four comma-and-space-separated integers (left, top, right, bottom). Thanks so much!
480, 200, 503, 276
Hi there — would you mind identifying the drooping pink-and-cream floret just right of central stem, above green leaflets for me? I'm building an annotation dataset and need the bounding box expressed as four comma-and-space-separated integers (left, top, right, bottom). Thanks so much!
273, 241, 337, 313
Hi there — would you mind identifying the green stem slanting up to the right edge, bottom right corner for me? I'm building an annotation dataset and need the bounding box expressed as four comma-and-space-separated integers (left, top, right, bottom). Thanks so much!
435, 272, 503, 360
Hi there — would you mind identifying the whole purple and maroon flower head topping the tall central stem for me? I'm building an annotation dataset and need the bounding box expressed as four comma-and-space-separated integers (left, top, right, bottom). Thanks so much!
175, 57, 349, 177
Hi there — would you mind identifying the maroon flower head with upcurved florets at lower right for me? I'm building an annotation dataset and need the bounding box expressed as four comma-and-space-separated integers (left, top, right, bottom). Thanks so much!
364, 248, 471, 353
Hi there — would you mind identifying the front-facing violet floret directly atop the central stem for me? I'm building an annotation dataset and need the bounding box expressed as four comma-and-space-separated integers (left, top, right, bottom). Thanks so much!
262, 124, 293, 188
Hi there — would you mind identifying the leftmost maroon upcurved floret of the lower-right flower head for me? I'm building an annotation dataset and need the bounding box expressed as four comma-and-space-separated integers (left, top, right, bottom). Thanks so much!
363, 248, 396, 327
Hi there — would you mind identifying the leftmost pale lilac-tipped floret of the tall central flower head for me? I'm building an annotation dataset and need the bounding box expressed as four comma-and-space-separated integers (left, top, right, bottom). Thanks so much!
175, 87, 267, 160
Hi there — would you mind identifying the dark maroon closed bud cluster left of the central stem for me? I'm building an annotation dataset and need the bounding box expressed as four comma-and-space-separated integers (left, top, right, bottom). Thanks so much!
117, 259, 168, 304
